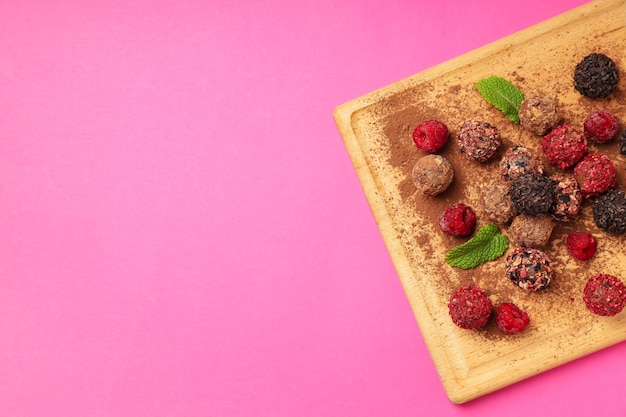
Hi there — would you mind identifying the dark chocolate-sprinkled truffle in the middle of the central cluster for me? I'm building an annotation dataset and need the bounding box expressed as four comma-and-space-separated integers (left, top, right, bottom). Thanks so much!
509, 171, 557, 216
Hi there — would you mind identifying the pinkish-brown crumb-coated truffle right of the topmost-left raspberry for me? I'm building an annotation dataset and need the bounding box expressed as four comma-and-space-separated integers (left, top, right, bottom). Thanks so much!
457, 120, 502, 162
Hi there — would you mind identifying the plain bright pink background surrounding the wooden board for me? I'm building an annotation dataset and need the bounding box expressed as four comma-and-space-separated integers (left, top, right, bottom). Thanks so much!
0, 0, 626, 417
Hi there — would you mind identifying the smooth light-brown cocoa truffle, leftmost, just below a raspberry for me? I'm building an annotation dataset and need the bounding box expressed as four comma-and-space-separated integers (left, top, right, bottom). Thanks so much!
412, 154, 454, 196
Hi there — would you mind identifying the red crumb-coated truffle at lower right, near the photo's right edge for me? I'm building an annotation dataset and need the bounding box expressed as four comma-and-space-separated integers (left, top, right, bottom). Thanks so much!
583, 274, 626, 316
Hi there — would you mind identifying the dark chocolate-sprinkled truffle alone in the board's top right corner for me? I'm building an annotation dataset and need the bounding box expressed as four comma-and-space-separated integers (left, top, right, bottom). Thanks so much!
574, 53, 619, 98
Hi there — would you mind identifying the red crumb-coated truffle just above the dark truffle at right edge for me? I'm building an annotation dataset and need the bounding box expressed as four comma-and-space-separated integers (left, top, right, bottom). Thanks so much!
574, 153, 617, 197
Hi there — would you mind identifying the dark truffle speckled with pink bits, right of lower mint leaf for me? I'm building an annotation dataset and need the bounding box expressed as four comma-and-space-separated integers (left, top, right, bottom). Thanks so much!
506, 247, 552, 291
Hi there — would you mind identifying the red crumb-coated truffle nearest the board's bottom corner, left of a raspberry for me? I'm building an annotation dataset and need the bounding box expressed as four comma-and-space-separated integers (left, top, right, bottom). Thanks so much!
448, 285, 493, 330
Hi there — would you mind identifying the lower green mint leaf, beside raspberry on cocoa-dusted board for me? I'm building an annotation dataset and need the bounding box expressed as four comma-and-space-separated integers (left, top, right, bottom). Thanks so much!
445, 224, 509, 269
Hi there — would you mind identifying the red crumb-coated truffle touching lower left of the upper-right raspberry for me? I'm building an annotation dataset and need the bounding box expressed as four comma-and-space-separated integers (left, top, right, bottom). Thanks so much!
541, 124, 587, 169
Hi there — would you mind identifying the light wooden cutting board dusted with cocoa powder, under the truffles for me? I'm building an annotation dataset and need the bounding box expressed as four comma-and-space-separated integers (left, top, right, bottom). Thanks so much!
334, 0, 626, 403
